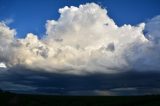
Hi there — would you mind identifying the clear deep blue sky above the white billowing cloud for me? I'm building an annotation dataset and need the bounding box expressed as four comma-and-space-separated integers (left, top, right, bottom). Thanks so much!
0, 0, 160, 38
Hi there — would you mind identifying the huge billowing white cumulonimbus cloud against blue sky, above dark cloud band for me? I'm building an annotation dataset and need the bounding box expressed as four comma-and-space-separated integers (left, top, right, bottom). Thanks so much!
0, 3, 160, 74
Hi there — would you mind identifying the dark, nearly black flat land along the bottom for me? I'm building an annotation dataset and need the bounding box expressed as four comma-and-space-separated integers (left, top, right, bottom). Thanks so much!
0, 92, 160, 106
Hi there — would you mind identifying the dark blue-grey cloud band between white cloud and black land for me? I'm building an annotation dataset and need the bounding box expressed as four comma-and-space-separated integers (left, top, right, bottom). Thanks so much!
0, 67, 160, 96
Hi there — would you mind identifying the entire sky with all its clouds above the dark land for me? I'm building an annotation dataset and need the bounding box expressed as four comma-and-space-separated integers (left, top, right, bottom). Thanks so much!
0, 0, 160, 95
